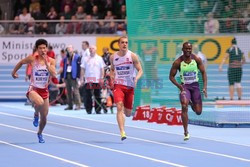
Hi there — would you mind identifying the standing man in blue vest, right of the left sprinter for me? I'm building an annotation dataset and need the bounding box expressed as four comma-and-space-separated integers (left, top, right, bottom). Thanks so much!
63, 45, 81, 110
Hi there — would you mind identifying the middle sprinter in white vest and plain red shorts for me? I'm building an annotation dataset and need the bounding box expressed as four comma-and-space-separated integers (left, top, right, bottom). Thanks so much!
110, 36, 143, 140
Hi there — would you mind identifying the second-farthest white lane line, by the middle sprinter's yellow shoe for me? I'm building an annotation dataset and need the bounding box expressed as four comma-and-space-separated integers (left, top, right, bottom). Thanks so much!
0, 112, 250, 162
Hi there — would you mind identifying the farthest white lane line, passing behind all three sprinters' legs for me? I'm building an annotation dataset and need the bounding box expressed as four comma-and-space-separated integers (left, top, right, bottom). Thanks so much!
0, 104, 250, 147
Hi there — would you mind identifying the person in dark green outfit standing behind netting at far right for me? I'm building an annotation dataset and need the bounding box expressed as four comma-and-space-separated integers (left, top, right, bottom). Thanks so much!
219, 38, 245, 100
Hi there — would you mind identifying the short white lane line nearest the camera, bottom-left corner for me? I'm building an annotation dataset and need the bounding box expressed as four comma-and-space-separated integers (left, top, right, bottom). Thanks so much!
0, 140, 88, 167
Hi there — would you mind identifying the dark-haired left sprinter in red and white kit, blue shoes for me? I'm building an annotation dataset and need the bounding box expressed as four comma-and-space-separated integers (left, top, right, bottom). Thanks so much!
12, 39, 56, 143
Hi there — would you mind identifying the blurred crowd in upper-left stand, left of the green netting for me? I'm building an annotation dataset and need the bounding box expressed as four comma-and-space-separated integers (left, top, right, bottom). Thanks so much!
0, 0, 127, 35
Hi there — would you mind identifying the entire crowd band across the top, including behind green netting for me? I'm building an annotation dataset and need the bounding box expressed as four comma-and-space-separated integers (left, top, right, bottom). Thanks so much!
0, 0, 250, 35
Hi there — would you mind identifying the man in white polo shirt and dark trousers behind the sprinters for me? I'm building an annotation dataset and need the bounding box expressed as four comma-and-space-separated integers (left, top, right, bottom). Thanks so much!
81, 45, 104, 114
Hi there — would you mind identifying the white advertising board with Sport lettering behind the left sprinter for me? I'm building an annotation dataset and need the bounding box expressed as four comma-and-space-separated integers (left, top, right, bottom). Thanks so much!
0, 36, 96, 65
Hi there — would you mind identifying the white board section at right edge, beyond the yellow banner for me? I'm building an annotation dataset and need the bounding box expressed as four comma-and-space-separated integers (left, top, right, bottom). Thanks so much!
235, 35, 250, 63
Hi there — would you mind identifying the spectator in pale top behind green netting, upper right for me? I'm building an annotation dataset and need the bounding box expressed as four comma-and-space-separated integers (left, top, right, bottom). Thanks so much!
204, 12, 220, 34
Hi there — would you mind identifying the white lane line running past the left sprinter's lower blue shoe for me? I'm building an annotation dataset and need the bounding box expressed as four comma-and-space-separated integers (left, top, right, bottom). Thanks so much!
0, 123, 186, 167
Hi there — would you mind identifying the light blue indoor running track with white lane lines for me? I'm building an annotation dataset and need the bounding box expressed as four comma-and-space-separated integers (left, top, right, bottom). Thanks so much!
0, 102, 250, 167
